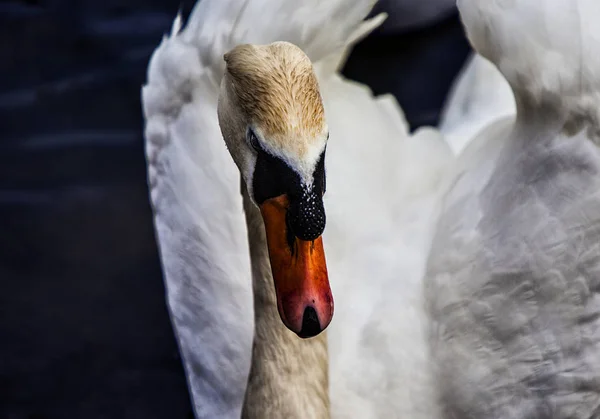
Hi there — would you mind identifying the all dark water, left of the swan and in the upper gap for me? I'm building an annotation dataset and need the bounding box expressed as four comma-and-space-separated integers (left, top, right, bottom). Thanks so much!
0, 0, 469, 419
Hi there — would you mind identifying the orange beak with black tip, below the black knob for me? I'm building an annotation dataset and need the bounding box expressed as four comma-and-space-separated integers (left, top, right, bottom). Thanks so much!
260, 195, 333, 338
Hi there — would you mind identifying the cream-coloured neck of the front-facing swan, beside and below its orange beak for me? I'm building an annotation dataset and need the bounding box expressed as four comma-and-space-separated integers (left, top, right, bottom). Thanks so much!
242, 186, 330, 419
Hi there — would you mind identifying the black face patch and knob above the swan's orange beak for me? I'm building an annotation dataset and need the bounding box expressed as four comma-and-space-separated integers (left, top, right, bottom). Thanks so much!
249, 130, 326, 244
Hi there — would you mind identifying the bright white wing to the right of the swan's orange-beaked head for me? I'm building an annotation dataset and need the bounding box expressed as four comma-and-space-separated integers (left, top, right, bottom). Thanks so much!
315, 36, 454, 419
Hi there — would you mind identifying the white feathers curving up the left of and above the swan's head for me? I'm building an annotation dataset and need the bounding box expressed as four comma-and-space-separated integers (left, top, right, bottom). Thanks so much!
142, 0, 381, 419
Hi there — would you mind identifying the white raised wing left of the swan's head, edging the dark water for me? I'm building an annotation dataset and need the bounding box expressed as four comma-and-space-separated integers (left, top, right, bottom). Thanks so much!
142, 17, 254, 418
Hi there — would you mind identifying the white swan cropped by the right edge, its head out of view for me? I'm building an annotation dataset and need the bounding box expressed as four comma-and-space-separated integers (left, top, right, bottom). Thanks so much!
425, 0, 600, 419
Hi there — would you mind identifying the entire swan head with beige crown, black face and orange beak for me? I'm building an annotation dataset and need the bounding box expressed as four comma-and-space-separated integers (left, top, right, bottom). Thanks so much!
218, 42, 333, 337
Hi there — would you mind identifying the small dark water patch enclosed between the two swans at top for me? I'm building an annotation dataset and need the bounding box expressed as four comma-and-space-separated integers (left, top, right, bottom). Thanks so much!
344, 13, 471, 129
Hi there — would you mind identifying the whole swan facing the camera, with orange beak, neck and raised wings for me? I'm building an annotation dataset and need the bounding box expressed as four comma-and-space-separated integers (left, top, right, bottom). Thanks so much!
142, 0, 454, 419
